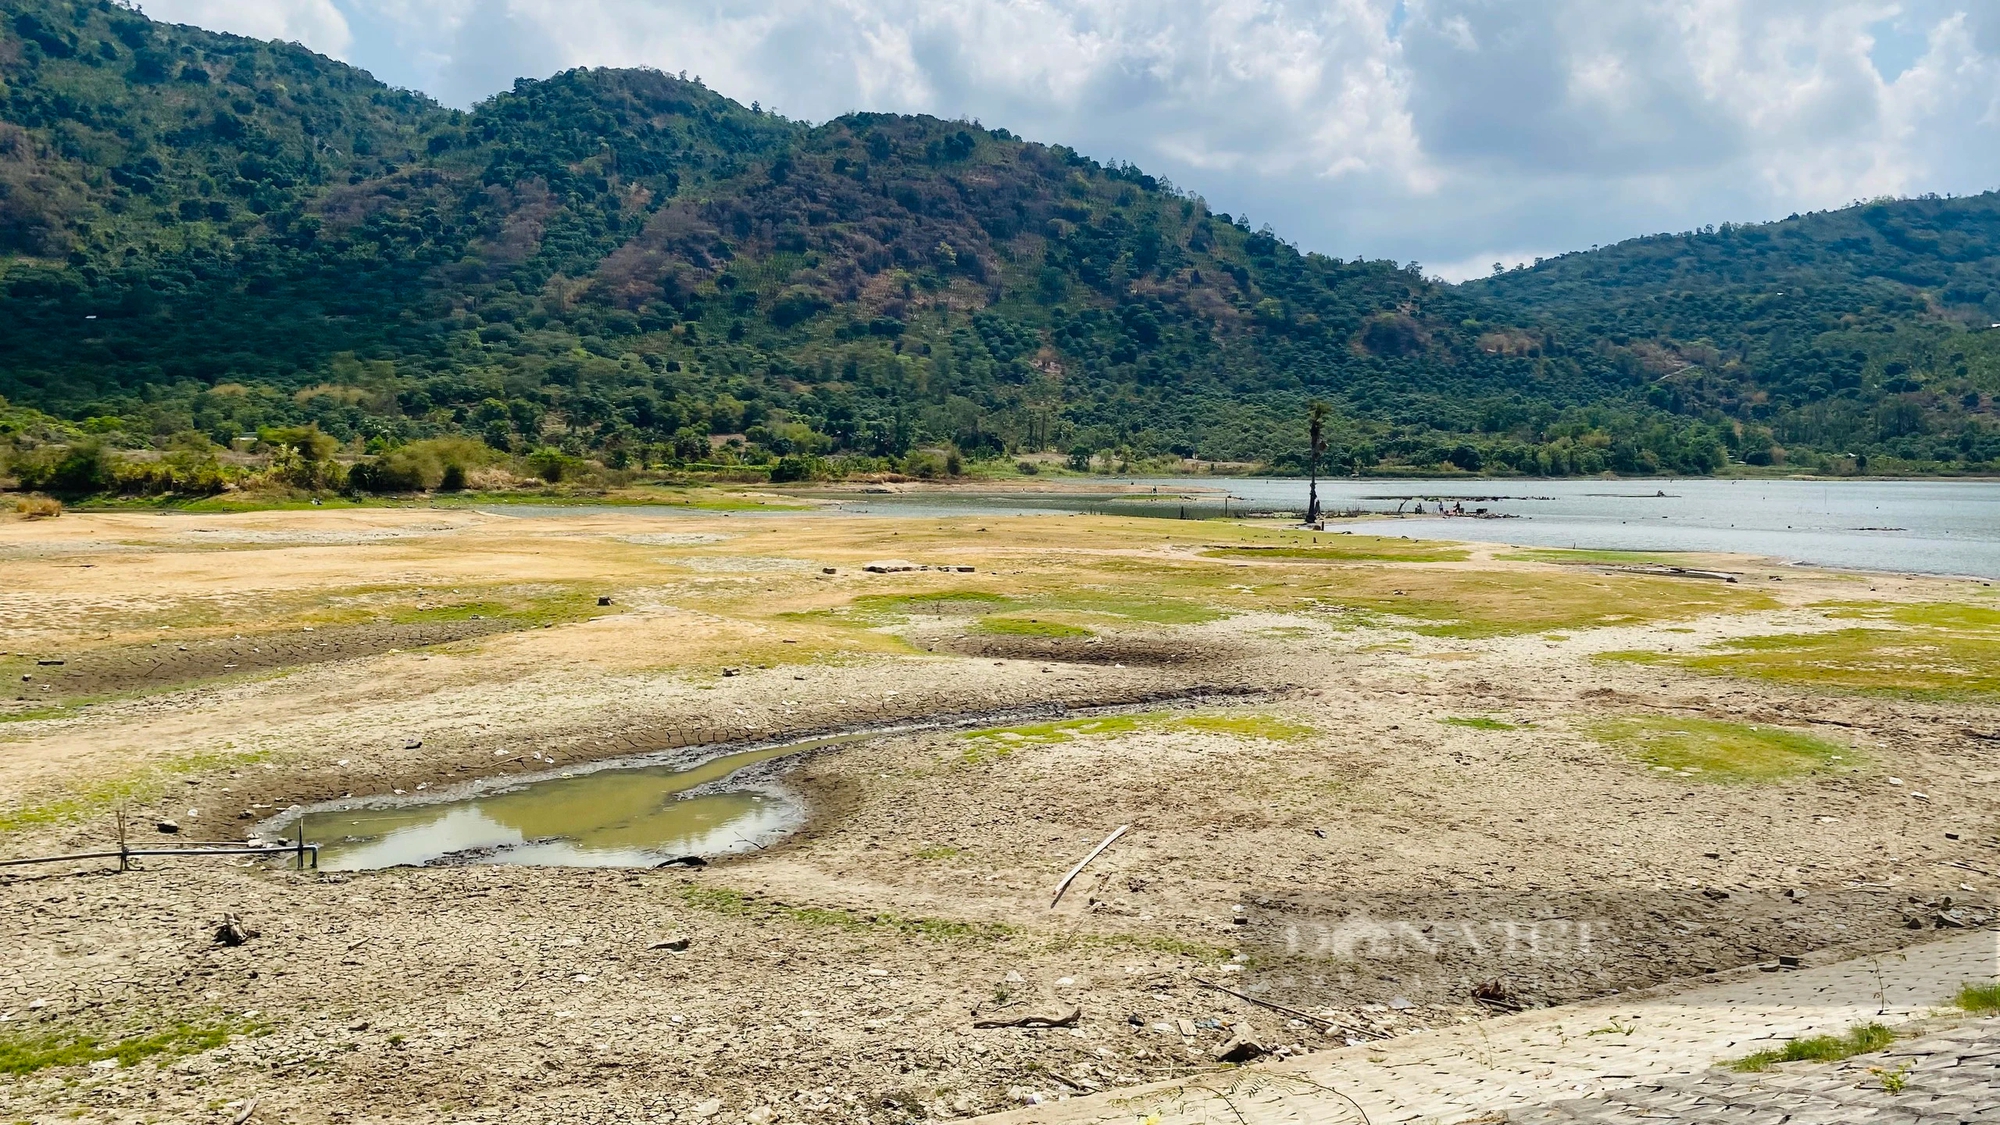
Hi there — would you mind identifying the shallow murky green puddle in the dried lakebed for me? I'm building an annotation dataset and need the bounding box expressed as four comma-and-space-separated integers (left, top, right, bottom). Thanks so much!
292, 745, 804, 871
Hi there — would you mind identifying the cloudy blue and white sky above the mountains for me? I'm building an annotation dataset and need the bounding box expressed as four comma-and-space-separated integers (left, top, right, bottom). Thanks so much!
144, 0, 2000, 280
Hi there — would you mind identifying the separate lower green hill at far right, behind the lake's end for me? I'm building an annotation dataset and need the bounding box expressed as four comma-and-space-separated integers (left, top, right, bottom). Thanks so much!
1464, 192, 2000, 462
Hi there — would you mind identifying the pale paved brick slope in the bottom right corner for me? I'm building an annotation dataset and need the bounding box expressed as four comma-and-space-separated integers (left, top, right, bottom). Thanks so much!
986, 931, 2000, 1125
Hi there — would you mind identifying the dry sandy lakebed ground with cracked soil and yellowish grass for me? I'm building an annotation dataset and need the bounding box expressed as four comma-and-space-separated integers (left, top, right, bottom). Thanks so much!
0, 500, 2000, 1125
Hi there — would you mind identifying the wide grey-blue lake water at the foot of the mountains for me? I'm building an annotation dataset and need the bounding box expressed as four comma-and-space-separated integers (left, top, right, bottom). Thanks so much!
796, 476, 2000, 579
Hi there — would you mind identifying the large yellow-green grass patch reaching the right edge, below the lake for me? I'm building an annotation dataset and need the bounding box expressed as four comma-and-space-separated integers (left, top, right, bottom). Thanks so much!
1598, 605, 2000, 701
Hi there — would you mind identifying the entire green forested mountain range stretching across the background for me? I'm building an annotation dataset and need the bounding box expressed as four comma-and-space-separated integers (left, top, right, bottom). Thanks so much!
0, 0, 2000, 486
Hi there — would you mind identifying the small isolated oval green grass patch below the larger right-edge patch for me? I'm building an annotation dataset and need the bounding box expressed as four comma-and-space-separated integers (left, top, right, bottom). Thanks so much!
1588, 715, 1856, 781
